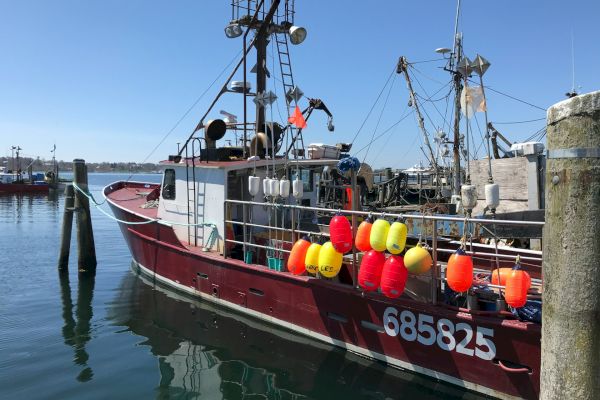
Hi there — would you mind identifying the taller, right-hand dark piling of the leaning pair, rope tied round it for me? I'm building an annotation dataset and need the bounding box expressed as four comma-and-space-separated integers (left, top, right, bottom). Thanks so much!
73, 159, 96, 272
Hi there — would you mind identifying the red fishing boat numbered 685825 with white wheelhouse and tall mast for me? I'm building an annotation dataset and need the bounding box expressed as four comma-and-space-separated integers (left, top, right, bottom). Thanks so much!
104, 0, 542, 399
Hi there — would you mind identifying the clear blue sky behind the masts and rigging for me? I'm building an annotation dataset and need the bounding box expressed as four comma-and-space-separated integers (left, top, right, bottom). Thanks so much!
0, 0, 600, 167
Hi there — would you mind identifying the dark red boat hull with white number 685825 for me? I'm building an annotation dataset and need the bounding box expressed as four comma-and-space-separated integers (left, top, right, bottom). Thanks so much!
109, 186, 540, 398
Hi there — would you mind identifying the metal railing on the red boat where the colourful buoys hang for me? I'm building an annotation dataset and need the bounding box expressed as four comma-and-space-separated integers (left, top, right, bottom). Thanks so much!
223, 199, 544, 303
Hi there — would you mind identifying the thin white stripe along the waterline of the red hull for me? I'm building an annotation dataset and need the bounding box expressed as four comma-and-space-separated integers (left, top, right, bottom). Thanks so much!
135, 261, 519, 399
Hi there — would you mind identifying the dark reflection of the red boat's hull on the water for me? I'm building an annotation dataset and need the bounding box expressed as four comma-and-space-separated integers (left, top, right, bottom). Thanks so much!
108, 267, 481, 399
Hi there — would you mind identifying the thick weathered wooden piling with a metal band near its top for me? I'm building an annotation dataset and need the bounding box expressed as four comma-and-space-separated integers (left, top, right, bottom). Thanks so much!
540, 91, 600, 400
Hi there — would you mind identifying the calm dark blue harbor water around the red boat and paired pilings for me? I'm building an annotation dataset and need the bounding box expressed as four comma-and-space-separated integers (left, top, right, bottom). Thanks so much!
0, 174, 488, 400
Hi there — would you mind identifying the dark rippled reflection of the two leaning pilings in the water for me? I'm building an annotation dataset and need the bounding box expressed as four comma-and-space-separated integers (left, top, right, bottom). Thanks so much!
59, 270, 96, 382
